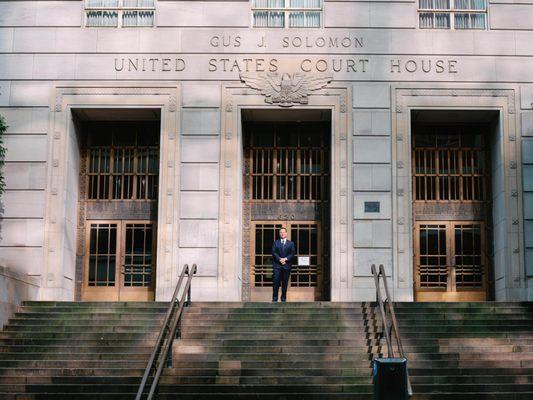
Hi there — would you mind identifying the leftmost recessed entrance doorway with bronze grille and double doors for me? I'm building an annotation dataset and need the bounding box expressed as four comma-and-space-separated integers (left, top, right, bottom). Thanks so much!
76, 110, 160, 301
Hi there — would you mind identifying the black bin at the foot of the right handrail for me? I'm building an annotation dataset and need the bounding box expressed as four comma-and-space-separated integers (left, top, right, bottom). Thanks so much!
372, 358, 409, 400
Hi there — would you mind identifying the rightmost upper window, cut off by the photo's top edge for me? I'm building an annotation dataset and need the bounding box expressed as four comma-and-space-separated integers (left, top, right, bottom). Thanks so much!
418, 0, 487, 29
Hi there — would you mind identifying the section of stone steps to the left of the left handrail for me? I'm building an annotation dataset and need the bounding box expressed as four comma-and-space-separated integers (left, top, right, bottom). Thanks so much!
0, 302, 167, 400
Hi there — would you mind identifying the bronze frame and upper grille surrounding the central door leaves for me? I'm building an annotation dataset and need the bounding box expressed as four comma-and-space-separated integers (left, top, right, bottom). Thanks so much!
242, 121, 331, 301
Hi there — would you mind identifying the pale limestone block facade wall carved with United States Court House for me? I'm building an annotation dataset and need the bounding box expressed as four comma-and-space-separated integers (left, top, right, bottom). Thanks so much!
0, 0, 533, 300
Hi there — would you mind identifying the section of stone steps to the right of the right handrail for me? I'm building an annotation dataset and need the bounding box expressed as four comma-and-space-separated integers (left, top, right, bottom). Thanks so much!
395, 302, 533, 400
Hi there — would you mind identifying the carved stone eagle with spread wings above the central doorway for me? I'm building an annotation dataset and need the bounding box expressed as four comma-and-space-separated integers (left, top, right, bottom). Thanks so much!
240, 72, 333, 107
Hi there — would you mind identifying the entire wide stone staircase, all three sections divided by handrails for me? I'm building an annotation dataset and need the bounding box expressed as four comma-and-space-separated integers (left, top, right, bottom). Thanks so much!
0, 302, 533, 400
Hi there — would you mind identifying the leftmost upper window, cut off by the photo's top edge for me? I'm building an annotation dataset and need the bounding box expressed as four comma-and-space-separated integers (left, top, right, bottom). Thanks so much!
85, 0, 155, 28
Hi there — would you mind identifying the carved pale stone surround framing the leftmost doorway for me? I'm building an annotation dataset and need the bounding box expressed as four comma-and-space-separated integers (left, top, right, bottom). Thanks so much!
41, 82, 179, 300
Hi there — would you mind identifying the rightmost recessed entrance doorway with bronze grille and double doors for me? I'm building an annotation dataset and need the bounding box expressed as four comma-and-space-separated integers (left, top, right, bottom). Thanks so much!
412, 113, 493, 301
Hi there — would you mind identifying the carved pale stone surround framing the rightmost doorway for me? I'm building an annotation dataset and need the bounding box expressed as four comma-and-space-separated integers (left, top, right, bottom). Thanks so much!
392, 83, 524, 300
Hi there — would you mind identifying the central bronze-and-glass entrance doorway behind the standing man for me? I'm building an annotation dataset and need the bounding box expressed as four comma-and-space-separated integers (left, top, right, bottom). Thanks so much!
243, 110, 331, 301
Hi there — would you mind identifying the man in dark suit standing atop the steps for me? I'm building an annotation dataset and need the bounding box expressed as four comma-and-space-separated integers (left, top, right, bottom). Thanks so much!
272, 228, 296, 302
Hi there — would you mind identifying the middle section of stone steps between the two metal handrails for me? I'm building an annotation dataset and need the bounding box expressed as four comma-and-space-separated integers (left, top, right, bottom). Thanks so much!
159, 302, 375, 400
